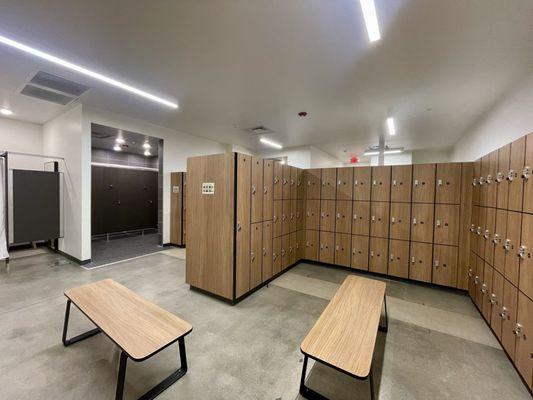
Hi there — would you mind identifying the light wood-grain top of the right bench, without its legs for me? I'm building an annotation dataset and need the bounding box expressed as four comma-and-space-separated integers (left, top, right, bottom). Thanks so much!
301, 275, 385, 378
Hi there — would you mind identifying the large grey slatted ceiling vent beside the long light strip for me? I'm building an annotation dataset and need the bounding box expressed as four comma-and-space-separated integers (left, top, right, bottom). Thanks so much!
20, 71, 89, 106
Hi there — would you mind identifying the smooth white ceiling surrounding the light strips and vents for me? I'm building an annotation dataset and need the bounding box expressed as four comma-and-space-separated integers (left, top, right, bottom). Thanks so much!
0, 0, 533, 159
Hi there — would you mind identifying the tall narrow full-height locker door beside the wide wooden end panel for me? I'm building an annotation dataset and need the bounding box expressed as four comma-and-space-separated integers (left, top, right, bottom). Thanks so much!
235, 153, 252, 297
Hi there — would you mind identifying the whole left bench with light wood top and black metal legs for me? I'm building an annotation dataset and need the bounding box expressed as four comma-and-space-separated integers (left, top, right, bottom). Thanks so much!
63, 279, 192, 400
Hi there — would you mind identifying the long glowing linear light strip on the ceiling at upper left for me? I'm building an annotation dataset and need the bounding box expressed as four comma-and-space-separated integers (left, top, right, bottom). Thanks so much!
0, 35, 178, 108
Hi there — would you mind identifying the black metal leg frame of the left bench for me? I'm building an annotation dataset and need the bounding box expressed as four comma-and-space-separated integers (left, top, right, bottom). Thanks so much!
62, 298, 189, 400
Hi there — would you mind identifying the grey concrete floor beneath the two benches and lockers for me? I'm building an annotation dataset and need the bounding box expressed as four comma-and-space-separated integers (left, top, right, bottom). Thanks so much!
0, 251, 530, 400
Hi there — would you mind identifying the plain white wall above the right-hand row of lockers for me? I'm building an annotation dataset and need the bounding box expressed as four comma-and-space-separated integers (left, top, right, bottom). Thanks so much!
451, 74, 533, 161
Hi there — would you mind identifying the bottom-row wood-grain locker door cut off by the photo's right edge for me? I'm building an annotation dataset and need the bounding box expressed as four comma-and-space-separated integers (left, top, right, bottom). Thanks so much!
515, 292, 533, 389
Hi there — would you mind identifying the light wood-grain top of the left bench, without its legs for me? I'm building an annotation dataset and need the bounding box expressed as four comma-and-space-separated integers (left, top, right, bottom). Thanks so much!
65, 279, 192, 361
